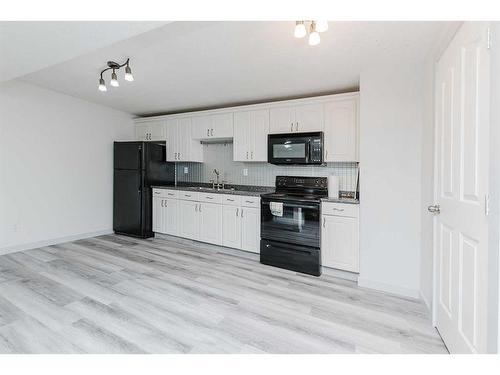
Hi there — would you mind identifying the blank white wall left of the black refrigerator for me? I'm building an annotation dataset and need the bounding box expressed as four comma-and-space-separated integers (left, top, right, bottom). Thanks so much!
0, 81, 133, 253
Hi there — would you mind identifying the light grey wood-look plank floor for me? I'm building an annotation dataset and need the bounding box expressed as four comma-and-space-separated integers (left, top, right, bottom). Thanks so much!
0, 235, 446, 353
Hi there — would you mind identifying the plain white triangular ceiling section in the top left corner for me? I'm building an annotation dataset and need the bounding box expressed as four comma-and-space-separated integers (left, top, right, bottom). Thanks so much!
0, 21, 166, 82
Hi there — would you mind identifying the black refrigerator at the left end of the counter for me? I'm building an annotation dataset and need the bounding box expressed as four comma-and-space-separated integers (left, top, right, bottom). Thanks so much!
113, 142, 175, 238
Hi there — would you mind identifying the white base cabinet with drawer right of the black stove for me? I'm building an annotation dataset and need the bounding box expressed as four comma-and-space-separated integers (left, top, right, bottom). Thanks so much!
321, 202, 359, 272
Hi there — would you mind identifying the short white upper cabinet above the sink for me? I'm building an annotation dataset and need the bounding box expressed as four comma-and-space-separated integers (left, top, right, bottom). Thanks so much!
192, 112, 233, 140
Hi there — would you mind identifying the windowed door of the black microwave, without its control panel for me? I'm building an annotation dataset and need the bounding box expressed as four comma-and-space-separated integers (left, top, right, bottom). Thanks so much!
267, 134, 310, 164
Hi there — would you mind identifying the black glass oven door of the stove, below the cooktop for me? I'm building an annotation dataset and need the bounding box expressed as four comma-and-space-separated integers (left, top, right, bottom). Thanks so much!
261, 198, 320, 248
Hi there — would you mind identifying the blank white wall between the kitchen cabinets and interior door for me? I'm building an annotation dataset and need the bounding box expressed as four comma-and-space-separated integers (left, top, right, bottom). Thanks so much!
359, 64, 424, 297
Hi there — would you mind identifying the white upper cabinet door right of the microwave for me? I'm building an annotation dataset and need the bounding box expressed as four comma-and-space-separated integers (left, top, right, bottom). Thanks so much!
324, 99, 358, 162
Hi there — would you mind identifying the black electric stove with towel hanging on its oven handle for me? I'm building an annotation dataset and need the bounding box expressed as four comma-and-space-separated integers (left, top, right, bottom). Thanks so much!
260, 176, 328, 276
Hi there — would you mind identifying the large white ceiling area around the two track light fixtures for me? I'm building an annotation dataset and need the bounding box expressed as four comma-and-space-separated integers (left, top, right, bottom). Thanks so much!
14, 21, 449, 115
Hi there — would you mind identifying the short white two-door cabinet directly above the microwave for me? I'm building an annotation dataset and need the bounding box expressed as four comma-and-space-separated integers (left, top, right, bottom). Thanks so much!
270, 103, 324, 134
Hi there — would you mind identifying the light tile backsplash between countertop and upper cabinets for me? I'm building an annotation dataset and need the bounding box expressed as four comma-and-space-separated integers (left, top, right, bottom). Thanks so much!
176, 143, 358, 191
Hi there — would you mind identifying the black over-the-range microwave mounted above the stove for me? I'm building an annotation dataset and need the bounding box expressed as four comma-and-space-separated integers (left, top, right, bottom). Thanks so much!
267, 132, 323, 165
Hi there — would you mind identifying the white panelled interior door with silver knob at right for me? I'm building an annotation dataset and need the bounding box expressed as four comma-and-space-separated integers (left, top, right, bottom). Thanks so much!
429, 22, 489, 353
